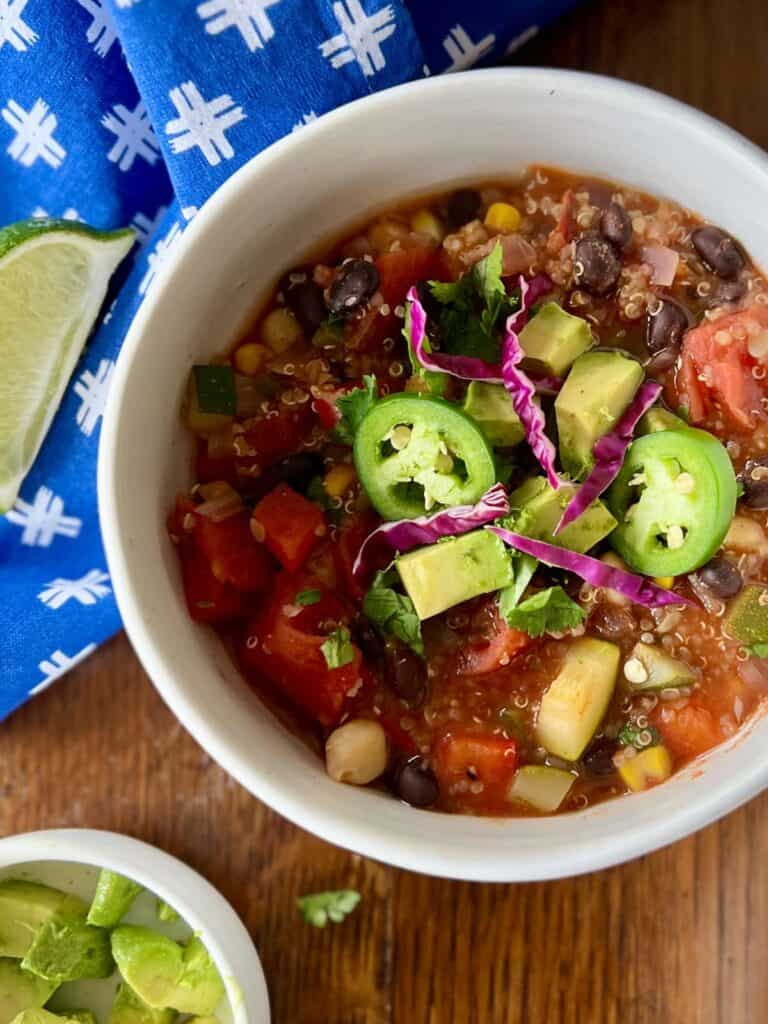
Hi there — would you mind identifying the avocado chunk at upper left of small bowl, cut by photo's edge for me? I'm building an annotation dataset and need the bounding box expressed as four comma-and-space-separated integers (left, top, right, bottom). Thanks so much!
0, 879, 87, 959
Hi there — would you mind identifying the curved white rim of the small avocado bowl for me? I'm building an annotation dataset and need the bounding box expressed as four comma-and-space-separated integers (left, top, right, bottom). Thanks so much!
0, 828, 270, 1024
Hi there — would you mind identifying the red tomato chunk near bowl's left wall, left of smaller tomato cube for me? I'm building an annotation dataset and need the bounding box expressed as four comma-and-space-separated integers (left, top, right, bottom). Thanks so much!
194, 511, 274, 593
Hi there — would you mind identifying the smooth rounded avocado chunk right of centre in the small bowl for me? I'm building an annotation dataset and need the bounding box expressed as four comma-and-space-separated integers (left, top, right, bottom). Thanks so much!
112, 925, 183, 1010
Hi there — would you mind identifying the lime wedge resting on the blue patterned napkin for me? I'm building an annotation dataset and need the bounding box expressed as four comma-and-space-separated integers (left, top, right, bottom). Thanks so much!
0, 220, 134, 513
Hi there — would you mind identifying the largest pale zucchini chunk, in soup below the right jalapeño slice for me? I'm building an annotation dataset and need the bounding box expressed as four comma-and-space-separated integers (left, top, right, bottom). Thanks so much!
536, 637, 622, 761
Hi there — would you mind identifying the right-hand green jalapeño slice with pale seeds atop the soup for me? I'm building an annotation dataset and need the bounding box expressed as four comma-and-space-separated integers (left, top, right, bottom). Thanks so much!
608, 427, 736, 577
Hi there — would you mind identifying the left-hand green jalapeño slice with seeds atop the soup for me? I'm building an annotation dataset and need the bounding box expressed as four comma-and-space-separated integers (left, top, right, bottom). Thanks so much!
354, 394, 496, 519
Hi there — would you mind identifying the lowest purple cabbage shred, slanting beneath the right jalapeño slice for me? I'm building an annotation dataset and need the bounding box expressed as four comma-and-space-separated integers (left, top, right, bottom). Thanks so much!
487, 526, 693, 608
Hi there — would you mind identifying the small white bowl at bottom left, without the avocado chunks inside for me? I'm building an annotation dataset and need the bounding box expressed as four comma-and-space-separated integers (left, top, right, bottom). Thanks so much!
0, 828, 269, 1024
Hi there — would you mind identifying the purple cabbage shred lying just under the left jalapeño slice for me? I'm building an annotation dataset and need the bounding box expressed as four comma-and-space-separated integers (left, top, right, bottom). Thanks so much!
352, 483, 509, 578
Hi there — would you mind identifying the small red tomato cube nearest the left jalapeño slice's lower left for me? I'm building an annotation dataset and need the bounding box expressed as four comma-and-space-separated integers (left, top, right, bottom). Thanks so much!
252, 483, 326, 572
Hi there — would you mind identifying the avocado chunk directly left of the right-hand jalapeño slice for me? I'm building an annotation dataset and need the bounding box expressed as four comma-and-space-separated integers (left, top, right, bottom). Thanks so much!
509, 476, 616, 554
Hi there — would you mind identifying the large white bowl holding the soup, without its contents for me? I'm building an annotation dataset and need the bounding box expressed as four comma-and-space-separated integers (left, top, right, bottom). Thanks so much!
99, 69, 768, 881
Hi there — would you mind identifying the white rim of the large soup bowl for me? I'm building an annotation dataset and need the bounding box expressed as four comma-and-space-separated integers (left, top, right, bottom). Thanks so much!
98, 67, 768, 882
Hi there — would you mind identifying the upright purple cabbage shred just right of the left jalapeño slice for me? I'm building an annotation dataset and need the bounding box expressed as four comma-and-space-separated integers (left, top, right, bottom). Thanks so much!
502, 276, 562, 488
